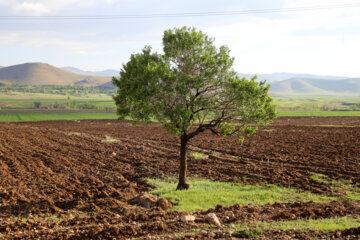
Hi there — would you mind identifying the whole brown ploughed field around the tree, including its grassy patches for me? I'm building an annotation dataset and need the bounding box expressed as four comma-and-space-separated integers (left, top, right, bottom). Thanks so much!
0, 117, 360, 239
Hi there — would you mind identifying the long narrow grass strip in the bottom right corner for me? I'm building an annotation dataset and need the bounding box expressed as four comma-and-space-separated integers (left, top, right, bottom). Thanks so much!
234, 216, 360, 232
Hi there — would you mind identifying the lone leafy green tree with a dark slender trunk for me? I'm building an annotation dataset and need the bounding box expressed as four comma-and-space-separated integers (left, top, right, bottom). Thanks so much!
112, 27, 276, 190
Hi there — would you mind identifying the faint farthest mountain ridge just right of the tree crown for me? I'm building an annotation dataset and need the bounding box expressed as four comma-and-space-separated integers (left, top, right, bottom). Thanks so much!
240, 72, 348, 83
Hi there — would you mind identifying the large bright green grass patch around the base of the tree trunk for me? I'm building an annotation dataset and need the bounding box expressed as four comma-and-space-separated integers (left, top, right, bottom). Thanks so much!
148, 179, 339, 211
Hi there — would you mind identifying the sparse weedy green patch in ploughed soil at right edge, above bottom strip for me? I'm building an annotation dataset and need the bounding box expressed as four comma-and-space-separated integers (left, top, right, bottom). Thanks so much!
310, 173, 360, 201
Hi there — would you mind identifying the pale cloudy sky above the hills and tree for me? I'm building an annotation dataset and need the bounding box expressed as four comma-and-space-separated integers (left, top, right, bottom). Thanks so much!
0, 0, 360, 77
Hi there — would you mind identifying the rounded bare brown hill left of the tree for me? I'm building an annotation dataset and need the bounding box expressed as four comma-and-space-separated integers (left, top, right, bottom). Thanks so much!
0, 63, 111, 86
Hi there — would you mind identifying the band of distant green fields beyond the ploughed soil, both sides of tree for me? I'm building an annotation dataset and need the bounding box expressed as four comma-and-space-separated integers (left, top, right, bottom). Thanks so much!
0, 88, 360, 122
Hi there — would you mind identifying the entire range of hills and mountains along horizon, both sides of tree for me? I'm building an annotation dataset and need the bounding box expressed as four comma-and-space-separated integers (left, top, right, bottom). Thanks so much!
0, 63, 360, 96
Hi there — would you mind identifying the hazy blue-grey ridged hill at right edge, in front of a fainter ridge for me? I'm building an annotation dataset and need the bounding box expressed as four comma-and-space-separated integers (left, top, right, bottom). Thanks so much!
270, 78, 360, 95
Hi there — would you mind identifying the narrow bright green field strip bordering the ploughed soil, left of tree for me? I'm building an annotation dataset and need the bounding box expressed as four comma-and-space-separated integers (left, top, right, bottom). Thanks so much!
0, 112, 117, 122
